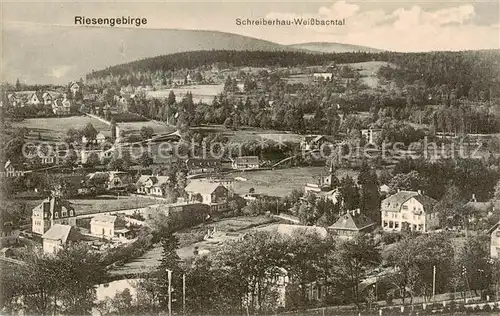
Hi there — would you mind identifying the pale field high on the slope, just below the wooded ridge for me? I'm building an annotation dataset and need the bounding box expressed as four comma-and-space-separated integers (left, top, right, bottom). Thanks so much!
147, 84, 224, 104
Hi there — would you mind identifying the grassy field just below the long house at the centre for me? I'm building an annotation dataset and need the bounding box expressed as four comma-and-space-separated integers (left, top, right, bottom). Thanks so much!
232, 167, 357, 197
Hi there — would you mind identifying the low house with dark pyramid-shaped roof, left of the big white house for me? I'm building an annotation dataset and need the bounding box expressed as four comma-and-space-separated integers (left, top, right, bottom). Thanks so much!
328, 209, 375, 239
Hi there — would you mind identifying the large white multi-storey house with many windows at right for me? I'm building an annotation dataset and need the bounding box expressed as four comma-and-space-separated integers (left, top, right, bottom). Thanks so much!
380, 191, 439, 232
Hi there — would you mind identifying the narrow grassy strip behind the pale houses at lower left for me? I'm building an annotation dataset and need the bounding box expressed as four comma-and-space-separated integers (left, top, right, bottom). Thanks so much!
20, 196, 158, 215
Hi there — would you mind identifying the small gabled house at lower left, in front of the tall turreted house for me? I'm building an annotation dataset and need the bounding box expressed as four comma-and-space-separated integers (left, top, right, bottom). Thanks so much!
42, 224, 82, 254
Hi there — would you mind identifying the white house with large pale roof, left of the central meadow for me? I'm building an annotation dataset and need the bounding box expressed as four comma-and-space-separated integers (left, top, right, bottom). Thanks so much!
185, 181, 229, 211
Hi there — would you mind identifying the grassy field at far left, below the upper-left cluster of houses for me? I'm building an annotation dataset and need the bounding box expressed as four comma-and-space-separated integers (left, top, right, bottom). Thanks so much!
12, 116, 110, 140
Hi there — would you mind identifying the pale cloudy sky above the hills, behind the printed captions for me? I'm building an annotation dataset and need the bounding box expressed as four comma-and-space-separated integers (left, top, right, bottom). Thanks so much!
1, 0, 500, 83
